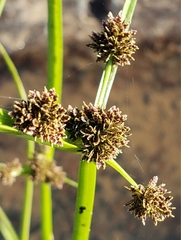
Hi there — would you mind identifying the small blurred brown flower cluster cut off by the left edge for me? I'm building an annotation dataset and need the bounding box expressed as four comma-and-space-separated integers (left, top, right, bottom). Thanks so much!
0, 158, 22, 186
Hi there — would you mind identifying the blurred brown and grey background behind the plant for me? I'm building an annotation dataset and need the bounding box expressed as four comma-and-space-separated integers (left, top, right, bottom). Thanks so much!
0, 0, 180, 240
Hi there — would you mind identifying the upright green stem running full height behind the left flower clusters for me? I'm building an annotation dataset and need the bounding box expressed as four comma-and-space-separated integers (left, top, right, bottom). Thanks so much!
41, 0, 63, 240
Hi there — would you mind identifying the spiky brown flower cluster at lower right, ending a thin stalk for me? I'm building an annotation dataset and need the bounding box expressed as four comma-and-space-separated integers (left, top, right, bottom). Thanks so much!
125, 176, 175, 226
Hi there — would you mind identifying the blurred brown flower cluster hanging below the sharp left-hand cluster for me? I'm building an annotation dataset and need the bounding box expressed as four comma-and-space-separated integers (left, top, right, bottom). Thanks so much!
29, 153, 66, 189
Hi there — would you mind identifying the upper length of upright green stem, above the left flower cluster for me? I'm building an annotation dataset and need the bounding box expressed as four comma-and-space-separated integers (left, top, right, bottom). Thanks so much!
48, 0, 63, 94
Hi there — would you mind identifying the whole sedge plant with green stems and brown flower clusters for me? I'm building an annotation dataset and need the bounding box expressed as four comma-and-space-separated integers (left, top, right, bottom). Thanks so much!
0, 0, 174, 240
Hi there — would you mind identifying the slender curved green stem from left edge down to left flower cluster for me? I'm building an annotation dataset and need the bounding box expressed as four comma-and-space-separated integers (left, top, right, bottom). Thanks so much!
0, 43, 27, 100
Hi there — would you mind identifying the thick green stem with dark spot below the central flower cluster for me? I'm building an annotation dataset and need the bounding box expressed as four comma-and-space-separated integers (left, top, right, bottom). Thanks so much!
73, 161, 97, 240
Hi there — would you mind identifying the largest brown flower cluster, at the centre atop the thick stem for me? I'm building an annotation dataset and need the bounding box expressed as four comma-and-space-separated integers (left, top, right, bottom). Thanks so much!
65, 103, 130, 169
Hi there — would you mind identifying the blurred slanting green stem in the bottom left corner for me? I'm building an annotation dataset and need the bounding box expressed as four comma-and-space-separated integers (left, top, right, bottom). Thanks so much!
0, 207, 19, 240
